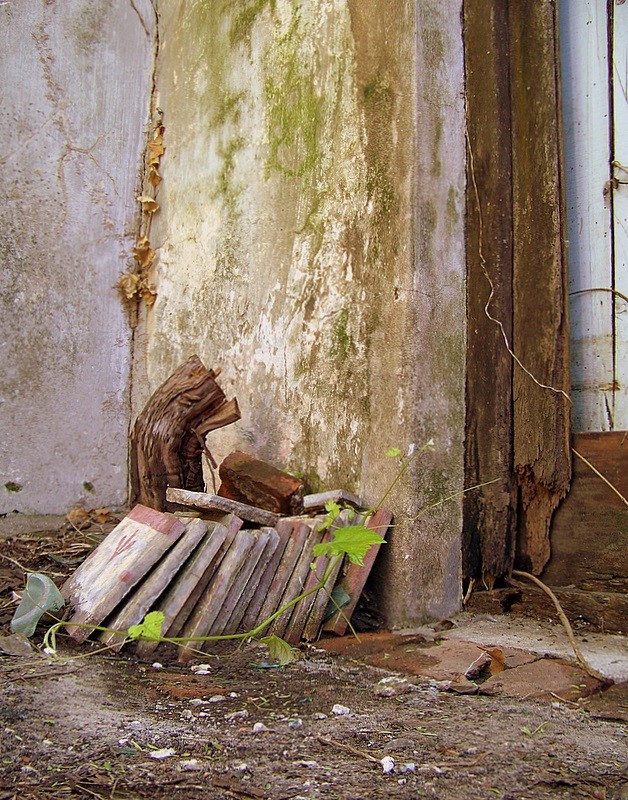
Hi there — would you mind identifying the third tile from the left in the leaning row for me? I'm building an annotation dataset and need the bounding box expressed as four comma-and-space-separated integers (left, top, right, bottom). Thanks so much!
135, 519, 233, 658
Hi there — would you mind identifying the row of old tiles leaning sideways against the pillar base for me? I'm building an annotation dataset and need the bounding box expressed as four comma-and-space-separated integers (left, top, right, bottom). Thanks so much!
61, 505, 392, 662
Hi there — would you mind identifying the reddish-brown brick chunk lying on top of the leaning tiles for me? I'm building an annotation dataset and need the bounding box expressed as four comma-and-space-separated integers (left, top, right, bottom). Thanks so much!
218, 450, 303, 515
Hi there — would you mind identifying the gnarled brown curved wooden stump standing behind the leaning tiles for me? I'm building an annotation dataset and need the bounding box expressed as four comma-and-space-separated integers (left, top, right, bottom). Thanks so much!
131, 356, 240, 511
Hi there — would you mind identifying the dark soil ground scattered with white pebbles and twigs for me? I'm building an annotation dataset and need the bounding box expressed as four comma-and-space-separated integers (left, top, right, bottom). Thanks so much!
0, 520, 628, 800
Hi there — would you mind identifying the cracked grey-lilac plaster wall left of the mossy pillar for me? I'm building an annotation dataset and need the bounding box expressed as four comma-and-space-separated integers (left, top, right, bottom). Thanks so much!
0, 0, 154, 513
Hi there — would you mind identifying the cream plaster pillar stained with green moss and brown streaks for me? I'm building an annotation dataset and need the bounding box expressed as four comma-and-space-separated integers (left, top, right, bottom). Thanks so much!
134, 0, 465, 626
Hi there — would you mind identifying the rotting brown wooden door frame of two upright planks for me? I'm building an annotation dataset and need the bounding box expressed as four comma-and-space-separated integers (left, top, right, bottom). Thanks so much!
463, 0, 571, 583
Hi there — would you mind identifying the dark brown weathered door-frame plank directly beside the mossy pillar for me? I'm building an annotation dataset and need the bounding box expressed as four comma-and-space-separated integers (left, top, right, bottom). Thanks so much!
462, 0, 517, 579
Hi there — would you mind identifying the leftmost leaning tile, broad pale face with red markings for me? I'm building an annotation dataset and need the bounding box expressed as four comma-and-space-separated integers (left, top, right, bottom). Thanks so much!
61, 505, 186, 642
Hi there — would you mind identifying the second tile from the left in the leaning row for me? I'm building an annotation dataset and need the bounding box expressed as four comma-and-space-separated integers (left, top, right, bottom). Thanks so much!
101, 519, 207, 649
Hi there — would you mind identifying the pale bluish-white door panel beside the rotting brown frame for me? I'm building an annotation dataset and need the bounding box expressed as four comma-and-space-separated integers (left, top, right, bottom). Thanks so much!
560, 0, 628, 431
